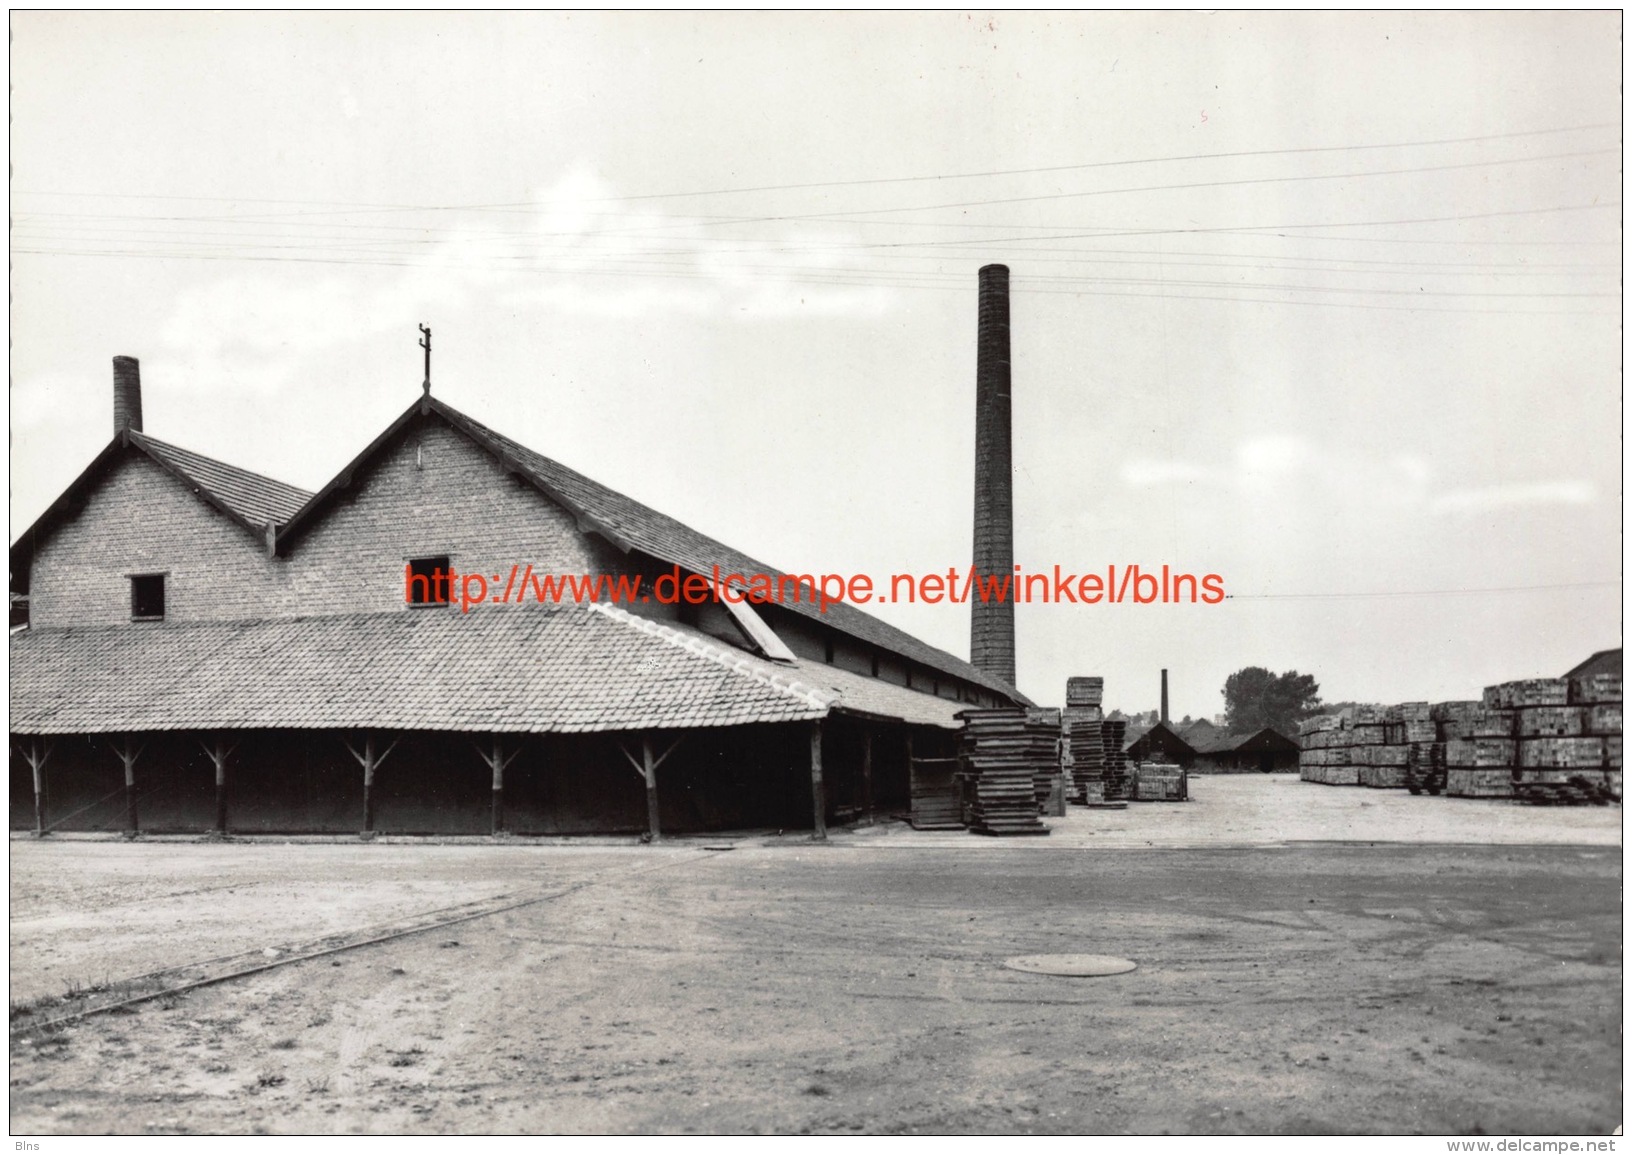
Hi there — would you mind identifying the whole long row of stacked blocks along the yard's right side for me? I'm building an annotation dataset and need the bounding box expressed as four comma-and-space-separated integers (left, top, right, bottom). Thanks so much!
1297, 674, 1621, 806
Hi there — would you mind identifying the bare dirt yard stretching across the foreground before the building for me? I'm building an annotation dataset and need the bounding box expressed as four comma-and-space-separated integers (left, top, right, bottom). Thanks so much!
10, 778, 1622, 1135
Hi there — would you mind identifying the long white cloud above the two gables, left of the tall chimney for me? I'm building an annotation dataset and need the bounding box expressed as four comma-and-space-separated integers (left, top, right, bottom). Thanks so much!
146, 165, 898, 393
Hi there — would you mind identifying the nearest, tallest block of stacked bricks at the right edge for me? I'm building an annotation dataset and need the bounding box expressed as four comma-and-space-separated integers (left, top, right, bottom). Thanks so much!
1485, 674, 1621, 806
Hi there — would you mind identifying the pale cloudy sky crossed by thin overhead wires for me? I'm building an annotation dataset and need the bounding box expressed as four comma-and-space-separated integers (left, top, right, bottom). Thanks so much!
10, 13, 1621, 715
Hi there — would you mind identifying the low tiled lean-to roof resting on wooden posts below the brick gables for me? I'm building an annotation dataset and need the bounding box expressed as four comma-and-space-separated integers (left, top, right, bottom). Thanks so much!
11, 605, 958, 734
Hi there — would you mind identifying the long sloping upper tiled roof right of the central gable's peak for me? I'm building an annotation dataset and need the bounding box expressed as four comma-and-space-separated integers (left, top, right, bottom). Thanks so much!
431, 406, 1025, 701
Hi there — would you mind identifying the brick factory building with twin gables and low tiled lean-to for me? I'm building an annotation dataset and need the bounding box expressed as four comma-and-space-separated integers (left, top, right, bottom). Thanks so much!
11, 357, 1028, 834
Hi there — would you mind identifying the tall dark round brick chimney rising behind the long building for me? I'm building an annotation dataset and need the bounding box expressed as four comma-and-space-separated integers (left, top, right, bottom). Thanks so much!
969, 264, 1015, 685
